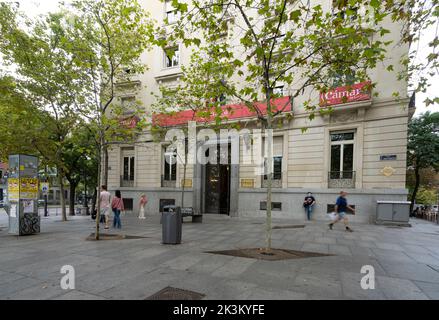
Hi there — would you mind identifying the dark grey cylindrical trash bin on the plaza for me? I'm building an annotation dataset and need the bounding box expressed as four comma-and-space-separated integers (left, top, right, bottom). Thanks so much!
162, 206, 182, 244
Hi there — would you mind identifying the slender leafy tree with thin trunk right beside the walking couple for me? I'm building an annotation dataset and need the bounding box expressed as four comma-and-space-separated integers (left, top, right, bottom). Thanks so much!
61, 0, 153, 239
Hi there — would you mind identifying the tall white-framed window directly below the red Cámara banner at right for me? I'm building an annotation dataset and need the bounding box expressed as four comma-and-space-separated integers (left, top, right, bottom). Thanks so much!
330, 132, 354, 179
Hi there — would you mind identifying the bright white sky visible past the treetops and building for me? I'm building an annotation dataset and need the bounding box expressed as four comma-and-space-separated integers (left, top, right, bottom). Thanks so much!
7, 0, 439, 116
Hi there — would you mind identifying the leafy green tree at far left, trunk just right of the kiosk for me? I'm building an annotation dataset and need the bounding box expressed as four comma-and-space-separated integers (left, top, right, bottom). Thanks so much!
0, 3, 87, 221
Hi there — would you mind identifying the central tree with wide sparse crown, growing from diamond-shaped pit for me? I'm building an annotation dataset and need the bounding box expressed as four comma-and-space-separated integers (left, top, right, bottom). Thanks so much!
157, 0, 400, 249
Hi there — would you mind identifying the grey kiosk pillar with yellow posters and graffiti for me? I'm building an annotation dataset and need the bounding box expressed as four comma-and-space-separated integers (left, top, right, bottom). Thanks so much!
7, 154, 40, 236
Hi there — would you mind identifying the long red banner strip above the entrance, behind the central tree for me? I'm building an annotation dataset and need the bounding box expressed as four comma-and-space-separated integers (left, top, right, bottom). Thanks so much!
152, 97, 291, 127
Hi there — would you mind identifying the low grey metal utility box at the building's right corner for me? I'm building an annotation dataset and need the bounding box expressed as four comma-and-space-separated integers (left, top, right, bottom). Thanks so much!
376, 200, 410, 227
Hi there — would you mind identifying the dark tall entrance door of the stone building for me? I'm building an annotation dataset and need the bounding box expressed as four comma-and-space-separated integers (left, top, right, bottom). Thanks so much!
204, 146, 230, 215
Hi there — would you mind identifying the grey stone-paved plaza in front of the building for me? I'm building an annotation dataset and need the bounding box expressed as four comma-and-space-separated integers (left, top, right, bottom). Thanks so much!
0, 212, 439, 299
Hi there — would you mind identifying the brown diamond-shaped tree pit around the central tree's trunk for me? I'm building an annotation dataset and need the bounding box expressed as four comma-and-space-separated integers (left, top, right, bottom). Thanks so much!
207, 248, 332, 261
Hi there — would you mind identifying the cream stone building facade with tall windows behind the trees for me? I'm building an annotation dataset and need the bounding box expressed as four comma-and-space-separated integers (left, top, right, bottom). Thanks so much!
108, 0, 414, 222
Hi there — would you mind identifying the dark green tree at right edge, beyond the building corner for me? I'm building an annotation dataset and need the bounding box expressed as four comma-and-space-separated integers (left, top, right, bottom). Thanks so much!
407, 112, 439, 212
